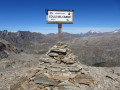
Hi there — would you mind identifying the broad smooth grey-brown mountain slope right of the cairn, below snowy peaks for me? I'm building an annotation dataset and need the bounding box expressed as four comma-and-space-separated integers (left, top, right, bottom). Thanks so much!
70, 34, 120, 66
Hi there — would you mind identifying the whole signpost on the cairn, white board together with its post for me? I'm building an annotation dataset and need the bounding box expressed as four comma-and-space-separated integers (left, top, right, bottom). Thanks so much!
45, 9, 74, 41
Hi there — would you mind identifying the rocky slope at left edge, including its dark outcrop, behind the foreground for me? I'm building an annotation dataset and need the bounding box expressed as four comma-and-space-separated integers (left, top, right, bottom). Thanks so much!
0, 39, 39, 72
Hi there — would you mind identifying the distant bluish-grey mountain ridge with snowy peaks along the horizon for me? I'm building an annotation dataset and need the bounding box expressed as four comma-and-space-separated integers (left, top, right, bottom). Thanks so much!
0, 29, 120, 46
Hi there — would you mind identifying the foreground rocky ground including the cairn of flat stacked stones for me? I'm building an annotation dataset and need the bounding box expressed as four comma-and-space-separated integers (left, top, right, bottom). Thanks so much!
0, 43, 120, 90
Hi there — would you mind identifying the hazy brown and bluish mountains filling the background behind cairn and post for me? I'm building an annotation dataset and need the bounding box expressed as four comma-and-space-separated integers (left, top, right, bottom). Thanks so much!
0, 29, 120, 66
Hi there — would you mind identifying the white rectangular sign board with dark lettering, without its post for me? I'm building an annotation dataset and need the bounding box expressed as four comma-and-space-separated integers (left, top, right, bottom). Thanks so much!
47, 10, 73, 24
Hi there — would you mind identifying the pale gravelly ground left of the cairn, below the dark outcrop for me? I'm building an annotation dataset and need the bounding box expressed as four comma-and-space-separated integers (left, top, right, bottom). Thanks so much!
0, 52, 40, 72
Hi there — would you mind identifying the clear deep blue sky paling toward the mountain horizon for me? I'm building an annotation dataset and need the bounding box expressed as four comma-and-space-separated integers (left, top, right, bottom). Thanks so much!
0, 0, 120, 33
